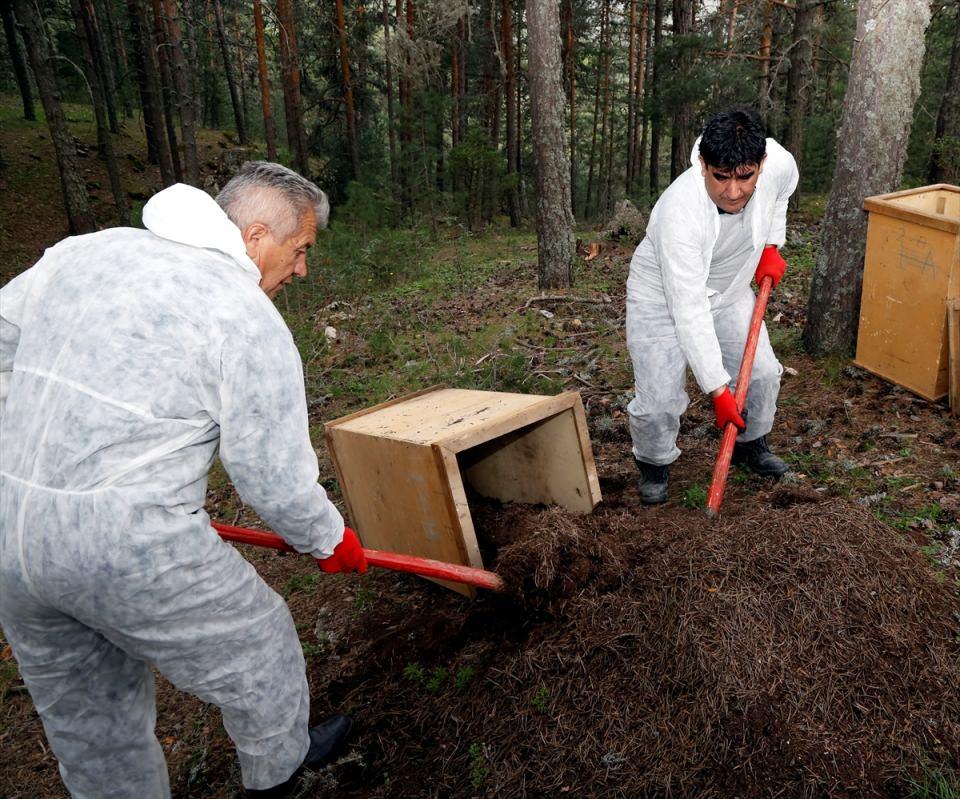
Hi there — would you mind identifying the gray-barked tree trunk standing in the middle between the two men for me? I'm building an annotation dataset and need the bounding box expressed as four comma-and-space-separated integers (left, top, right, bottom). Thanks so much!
527, 0, 576, 289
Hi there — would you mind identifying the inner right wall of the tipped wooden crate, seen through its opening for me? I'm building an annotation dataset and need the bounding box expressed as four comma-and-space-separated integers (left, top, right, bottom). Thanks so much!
459, 408, 596, 513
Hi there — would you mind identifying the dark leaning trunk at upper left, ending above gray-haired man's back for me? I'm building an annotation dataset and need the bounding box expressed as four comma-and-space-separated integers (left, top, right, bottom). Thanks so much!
13, 0, 97, 234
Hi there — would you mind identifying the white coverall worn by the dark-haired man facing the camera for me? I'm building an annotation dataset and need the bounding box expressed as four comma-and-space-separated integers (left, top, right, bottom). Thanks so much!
627, 139, 799, 465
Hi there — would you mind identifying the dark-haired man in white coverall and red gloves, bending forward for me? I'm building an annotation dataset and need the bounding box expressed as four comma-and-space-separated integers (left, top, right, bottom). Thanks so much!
627, 108, 799, 505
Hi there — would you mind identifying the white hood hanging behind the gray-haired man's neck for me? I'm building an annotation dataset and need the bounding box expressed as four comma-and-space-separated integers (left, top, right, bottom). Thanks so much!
143, 183, 260, 280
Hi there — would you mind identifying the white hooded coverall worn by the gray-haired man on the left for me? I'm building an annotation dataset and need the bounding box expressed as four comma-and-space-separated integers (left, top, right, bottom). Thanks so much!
0, 185, 344, 799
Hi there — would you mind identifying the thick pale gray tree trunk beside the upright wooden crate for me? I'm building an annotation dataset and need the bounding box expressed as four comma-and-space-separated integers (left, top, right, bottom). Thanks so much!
803, 0, 930, 355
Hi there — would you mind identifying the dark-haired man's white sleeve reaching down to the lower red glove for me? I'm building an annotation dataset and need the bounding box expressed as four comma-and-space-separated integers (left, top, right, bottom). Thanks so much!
653, 209, 730, 393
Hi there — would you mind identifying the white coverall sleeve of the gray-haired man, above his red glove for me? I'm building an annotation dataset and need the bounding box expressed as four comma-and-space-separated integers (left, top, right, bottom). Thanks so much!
217, 317, 344, 558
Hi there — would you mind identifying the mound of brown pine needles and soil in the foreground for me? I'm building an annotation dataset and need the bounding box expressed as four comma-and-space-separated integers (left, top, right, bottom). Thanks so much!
307, 500, 960, 797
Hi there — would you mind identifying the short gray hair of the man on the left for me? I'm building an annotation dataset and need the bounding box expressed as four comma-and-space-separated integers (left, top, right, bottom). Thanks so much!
217, 161, 330, 241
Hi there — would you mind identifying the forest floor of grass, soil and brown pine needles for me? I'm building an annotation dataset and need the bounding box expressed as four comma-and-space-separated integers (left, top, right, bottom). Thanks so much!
0, 97, 960, 799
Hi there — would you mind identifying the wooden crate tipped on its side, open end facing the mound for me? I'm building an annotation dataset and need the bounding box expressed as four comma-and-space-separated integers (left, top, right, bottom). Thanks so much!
325, 386, 600, 596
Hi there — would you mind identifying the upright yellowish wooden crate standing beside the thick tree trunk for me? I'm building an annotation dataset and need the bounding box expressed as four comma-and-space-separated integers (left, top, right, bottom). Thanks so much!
855, 183, 960, 400
